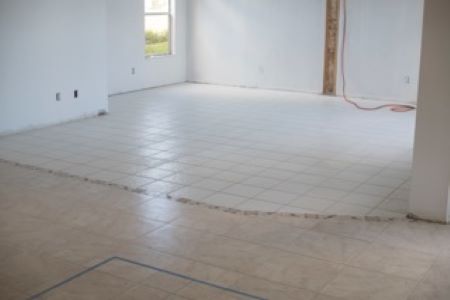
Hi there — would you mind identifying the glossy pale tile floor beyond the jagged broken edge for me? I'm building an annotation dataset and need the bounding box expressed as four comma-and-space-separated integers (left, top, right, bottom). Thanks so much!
0, 84, 415, 217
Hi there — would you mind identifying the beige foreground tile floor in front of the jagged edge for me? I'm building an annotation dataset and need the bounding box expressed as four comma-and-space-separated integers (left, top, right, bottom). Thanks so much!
0, 163, 450, 300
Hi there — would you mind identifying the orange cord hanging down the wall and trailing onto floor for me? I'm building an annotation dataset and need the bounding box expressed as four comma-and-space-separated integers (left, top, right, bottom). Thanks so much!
341, 0, 416, 112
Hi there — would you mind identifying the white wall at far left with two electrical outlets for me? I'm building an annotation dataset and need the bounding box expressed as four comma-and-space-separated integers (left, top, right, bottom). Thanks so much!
0, 0, 107, 134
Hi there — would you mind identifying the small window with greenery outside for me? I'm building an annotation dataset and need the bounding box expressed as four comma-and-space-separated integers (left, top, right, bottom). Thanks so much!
145, 0, 173, 56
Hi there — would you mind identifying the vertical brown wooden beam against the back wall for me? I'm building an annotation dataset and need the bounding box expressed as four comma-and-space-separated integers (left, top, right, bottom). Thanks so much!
323, 0, 341, 96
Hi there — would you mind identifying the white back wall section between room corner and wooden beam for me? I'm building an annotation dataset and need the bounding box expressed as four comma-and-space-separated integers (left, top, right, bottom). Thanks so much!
188, 0, 325, 92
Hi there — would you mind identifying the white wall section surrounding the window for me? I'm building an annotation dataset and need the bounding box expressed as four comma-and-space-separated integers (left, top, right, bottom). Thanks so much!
107, 0, 188, 94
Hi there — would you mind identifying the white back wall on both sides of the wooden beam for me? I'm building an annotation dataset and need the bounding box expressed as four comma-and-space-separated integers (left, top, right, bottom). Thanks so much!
188, 0, 423, 101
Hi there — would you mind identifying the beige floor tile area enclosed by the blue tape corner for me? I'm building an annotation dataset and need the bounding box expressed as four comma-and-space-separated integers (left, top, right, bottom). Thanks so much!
31, 257, 265, 300
